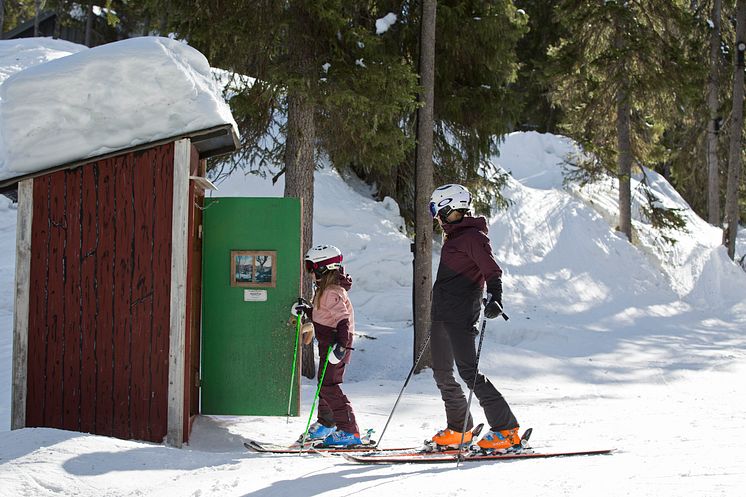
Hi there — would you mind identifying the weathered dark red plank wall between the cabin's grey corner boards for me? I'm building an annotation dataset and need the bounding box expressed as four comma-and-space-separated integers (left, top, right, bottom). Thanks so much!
26, 143, 174, 442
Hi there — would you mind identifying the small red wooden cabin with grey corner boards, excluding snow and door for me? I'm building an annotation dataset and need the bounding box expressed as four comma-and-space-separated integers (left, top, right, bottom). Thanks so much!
8, 125, 237, 446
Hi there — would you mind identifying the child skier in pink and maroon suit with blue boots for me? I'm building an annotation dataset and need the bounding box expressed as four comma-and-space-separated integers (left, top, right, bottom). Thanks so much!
293, 245, 362, 447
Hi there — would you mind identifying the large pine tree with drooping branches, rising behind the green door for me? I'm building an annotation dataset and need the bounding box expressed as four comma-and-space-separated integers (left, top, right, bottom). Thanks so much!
153, 0, 416, 377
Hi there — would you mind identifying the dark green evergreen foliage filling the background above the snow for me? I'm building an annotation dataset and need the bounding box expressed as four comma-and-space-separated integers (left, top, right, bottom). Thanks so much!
4, 0, 746, 239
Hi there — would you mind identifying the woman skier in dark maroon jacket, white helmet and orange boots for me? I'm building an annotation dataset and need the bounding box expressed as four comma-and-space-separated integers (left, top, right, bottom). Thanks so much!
430, 185, 521, 451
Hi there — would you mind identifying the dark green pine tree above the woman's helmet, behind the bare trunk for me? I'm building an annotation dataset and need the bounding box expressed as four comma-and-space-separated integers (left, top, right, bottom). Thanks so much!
355, 0, 527, 223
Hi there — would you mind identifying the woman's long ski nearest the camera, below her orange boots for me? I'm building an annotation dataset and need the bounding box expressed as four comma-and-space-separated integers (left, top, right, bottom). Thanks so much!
342, 449, 614, 464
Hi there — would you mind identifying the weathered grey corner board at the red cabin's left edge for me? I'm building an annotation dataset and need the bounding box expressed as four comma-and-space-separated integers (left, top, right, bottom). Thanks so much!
10, 179, 34, 430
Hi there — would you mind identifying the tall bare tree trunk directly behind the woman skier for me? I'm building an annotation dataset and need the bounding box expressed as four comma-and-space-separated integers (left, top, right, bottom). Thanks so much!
412, 0, 436, 372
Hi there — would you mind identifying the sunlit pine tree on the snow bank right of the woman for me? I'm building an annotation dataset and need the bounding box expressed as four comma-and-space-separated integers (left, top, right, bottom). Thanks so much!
551, 0, 701, 241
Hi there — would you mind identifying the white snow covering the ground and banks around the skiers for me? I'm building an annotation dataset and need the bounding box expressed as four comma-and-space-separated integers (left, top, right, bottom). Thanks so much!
0, 38, 746, 497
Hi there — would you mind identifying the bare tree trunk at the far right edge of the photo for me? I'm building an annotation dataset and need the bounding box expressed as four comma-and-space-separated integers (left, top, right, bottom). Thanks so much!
723, 0, 746, 259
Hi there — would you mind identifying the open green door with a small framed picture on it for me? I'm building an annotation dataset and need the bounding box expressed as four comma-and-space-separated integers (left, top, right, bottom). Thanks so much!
201, 197, 302, 416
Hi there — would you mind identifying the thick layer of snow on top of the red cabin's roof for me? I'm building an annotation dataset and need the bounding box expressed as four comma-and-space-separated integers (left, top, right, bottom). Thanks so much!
0, 37, 237, 181
